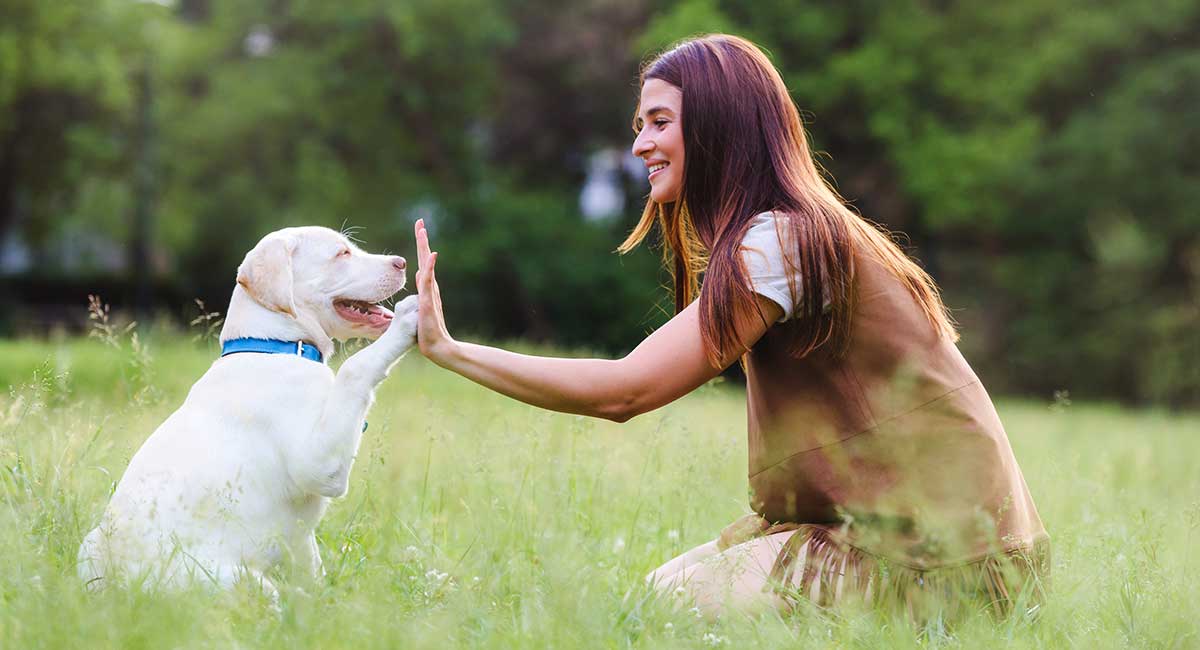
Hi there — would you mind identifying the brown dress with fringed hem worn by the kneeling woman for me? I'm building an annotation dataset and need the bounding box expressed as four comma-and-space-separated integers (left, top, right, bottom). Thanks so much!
721, 250, 1050, 618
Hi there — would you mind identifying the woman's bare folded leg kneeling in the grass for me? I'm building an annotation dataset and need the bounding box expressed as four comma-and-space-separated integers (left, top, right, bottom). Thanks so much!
652, 530, 804, 618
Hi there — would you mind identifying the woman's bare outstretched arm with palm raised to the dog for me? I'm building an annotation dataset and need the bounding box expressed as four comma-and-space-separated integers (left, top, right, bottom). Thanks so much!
416, 222, 784, 422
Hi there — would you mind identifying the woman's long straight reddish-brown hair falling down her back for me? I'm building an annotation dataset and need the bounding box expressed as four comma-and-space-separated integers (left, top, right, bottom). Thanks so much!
618, 34, 958, 366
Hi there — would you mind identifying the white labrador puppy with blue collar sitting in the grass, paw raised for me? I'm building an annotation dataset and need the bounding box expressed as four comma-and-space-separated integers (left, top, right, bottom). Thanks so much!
79, 227, 416, 595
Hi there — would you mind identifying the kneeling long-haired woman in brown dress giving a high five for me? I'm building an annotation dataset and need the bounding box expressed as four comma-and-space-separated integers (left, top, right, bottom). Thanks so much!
416, 35, 1049, 616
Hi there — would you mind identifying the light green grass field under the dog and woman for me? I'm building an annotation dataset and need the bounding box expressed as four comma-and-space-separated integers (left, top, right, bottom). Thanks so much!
0, 335, 1200, 649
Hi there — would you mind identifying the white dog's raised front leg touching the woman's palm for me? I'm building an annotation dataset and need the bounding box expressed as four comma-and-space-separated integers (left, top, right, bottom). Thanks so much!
292, 296, 416, 496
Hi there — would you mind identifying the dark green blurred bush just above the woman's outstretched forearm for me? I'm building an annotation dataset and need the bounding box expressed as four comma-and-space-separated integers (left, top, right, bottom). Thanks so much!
431, 188, 666, 350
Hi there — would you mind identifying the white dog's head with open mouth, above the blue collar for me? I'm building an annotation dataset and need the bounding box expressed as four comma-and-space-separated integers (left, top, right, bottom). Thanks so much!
238, 227, 406, 341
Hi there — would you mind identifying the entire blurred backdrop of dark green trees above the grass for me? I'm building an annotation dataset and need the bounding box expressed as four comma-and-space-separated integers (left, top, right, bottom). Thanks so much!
0, 0, 1200, 405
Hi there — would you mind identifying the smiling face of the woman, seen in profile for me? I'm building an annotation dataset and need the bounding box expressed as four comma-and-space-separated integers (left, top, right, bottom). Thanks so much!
634, 79, 683, 203
